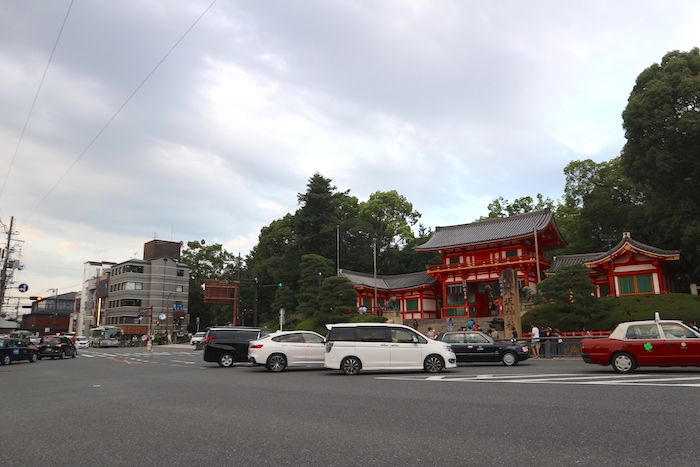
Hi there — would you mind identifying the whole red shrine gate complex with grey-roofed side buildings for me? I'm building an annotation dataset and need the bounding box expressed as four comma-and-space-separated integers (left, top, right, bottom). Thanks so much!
340, 209, 689, 320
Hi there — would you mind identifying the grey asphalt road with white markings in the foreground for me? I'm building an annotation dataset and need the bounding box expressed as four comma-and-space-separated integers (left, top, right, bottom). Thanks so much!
0, 345, 700, 467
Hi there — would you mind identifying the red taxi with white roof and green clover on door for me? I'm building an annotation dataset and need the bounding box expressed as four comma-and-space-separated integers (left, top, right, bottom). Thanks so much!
581, 313, 700, 373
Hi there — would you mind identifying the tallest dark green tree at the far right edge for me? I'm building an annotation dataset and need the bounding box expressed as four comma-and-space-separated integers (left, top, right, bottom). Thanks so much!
622, 47, 700, 282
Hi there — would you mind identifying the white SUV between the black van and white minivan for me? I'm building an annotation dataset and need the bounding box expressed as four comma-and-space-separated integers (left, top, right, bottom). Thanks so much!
248, 331, 326, 371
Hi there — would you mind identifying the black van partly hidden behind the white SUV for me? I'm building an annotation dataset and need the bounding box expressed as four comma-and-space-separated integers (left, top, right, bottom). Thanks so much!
204, 326, 272, 366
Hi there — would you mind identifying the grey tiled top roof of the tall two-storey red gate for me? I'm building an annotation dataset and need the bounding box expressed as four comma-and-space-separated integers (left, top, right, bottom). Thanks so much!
415, 209, 566, 251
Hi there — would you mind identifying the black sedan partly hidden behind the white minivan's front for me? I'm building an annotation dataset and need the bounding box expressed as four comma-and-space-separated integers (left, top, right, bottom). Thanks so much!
438, 331, 530, 366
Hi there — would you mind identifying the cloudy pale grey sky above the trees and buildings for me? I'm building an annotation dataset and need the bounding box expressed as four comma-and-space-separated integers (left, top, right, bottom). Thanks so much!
0, 0, 700, 312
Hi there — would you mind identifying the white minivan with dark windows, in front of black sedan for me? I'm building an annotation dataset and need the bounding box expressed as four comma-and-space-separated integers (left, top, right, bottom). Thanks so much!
324, 323, 457, 375
